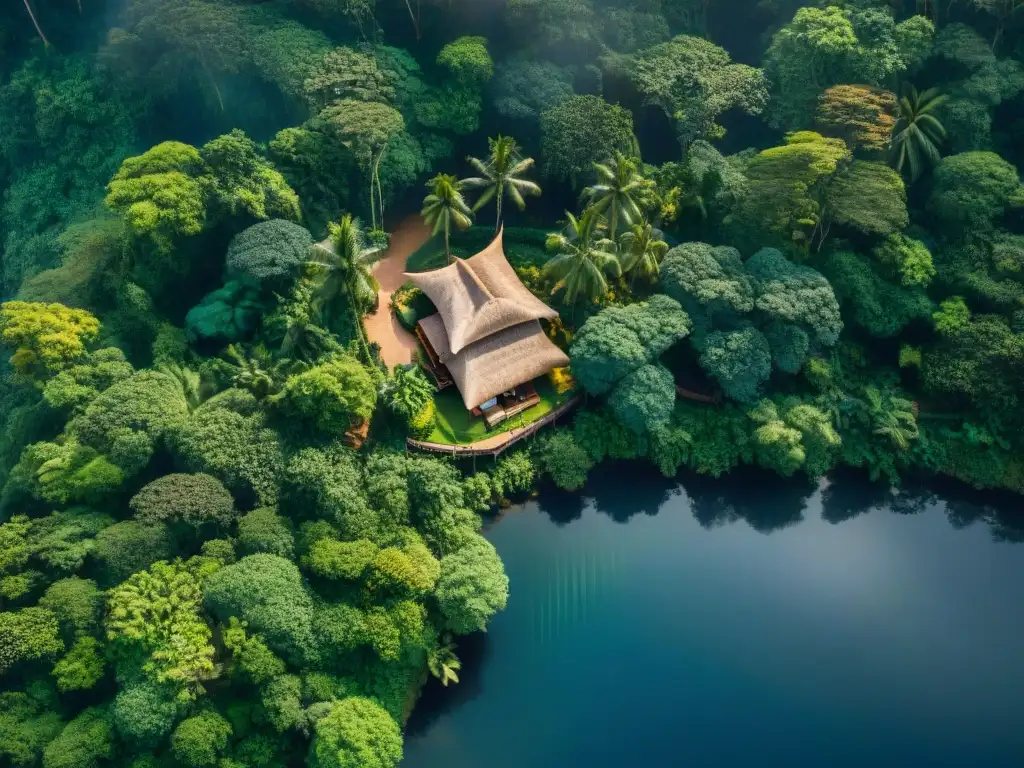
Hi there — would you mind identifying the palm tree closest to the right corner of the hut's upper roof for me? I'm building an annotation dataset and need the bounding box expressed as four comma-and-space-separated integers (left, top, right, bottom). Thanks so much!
544, 206, 622, 317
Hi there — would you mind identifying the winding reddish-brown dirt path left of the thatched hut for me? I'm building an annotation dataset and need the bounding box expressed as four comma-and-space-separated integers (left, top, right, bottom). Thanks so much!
364, 215, 430, 369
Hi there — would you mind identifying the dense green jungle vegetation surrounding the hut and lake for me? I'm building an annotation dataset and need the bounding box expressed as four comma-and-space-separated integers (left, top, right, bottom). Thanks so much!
0, 0, 1024, 768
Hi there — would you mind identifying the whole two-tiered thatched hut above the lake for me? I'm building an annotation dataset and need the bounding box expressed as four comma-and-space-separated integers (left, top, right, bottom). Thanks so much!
404, 231, 568, 426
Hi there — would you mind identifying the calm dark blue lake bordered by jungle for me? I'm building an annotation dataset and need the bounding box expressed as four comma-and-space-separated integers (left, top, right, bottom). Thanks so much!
402, 465, 1024, 768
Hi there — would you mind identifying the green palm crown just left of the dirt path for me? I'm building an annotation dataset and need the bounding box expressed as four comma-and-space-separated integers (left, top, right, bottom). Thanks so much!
309, 213, 384, 318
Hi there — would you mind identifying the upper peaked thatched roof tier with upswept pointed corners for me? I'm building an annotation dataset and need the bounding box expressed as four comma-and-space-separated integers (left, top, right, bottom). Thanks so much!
406, 230, 558, 353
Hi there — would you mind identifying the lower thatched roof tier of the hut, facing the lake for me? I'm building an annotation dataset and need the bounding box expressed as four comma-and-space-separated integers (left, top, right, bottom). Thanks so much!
420, 313, 569, 410
